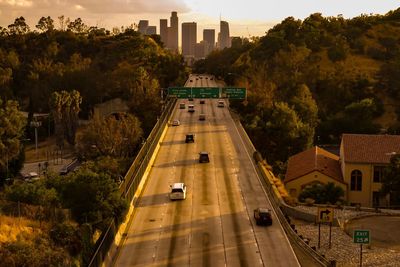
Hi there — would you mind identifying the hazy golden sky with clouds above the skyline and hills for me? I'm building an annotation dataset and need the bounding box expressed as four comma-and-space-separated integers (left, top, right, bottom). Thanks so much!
0, 0, 400, 41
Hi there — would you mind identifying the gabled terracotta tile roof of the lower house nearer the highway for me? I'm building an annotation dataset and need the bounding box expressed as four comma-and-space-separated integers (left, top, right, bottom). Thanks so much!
284, 146, 344, 183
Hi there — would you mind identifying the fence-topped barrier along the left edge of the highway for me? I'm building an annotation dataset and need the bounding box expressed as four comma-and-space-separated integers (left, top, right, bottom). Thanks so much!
88, 99, 176, 267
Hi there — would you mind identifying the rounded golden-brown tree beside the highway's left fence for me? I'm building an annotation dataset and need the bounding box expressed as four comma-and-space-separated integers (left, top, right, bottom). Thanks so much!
77, 114, 143, 159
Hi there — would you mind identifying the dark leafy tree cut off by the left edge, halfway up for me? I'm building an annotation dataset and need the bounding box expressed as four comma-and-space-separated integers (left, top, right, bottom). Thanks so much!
0, 99, 26, 182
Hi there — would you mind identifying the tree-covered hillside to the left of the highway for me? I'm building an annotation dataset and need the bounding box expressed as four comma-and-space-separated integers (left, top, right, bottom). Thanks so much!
0, 16, 187, 266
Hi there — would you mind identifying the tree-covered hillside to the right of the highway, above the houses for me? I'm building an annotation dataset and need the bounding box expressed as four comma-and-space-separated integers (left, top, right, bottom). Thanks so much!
194, 9, 400, 174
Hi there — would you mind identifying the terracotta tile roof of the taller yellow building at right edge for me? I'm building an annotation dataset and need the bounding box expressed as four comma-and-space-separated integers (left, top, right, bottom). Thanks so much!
342, 134, 400, 163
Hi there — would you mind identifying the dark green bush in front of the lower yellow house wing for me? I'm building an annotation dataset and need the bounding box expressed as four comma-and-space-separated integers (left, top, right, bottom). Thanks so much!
299, 182, 344, 204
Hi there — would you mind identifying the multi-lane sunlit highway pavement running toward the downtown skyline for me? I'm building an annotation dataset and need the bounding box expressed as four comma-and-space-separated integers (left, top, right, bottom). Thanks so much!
114, 75, 299, 267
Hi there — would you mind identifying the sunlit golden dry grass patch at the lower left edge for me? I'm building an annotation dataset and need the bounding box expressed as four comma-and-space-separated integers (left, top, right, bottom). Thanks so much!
0, 215, 47, 244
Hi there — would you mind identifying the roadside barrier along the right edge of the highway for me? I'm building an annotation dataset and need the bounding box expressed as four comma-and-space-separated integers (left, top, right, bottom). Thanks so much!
231, 112, 335, 266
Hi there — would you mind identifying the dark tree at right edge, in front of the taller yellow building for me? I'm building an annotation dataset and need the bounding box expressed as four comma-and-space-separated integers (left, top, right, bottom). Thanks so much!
381, 154, 400, 205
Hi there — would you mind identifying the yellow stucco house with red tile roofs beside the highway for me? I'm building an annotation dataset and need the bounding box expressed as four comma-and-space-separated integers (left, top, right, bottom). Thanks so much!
284, 134, 400, 207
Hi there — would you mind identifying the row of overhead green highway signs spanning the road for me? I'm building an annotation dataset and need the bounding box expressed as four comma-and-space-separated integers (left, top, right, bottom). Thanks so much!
168, 87, 246, 99
